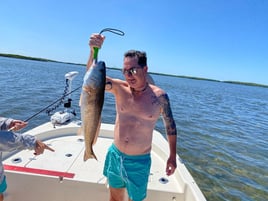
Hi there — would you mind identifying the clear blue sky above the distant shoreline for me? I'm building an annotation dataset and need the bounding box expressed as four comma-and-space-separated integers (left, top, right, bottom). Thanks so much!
0, 0, 268, 85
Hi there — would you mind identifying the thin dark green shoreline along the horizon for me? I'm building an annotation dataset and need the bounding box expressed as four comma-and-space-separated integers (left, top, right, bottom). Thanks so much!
0, 53, 268, 88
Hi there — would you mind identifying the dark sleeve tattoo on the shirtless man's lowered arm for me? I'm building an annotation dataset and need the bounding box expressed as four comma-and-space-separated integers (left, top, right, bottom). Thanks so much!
159, 94, 177, 135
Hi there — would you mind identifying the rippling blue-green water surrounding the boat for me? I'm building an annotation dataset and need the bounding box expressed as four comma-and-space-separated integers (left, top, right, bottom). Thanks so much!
0, 57, 268, 201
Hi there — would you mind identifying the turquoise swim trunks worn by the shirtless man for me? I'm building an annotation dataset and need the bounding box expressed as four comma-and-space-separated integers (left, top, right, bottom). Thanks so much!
103, 144, 151, 201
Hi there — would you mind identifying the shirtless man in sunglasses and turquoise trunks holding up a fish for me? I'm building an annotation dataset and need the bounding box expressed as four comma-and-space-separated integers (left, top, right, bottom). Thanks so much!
87, 34, 177, 201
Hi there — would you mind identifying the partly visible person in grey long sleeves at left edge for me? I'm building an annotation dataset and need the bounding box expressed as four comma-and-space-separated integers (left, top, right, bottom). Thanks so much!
0, 117, 54, 201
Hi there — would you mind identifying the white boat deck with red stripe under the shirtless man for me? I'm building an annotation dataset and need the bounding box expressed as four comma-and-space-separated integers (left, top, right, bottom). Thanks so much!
3, 71, 206, 201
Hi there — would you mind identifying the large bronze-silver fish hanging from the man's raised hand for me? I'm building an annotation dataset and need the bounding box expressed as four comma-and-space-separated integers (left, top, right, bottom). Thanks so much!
80, 61, 106, 161
